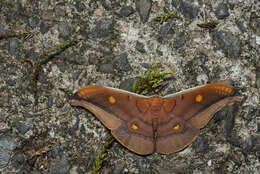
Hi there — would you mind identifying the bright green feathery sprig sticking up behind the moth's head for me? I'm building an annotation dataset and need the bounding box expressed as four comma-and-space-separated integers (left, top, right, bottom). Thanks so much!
133, 62, 175, 95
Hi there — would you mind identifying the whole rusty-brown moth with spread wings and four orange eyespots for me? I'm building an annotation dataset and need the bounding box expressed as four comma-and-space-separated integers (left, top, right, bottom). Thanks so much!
69, 82, 242, 155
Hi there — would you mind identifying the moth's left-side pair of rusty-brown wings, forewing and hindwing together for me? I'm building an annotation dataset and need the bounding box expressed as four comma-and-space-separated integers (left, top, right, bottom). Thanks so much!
70, 86, 154, 155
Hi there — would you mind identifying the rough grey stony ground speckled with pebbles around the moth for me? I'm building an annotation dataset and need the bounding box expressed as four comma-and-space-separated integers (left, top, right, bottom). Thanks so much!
0, 0, 260, 174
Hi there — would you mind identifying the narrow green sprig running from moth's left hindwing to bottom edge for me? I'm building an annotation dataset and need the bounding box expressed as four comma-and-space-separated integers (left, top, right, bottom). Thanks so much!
92, 137, 114, 174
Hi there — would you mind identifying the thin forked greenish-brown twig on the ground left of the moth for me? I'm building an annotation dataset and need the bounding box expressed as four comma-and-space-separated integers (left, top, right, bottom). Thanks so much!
25, 40, 78, 105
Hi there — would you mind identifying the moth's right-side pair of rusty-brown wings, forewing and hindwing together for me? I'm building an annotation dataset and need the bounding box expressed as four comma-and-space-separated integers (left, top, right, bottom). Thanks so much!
155, 83, 241, 154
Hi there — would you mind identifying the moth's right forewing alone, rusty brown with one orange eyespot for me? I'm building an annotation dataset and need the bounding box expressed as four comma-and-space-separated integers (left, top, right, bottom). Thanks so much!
164, 82, 241, 128
